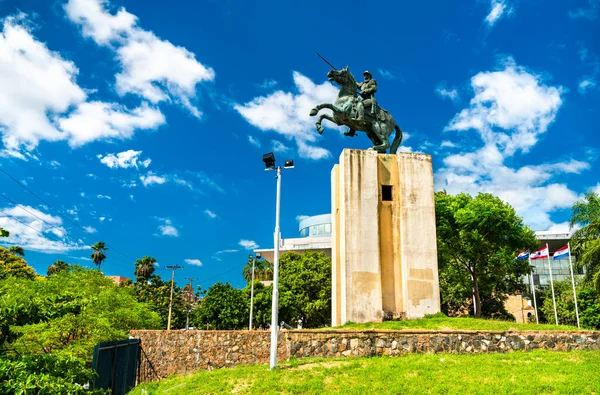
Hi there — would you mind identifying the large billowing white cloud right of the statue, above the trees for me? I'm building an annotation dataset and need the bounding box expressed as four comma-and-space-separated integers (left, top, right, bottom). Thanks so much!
435, 61, 590, 230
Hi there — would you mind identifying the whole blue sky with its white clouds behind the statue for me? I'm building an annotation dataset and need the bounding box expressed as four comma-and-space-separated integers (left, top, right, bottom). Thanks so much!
0, 0, 600, 288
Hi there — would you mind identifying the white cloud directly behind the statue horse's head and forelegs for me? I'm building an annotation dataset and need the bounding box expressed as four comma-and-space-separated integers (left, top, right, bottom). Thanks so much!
234, 72, 338, 160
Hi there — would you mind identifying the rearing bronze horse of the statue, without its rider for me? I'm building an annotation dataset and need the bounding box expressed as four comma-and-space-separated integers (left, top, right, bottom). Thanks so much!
310, 67, 402, 154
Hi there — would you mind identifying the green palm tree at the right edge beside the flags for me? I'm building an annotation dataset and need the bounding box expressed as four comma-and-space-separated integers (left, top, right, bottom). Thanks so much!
570, 191, 600, 291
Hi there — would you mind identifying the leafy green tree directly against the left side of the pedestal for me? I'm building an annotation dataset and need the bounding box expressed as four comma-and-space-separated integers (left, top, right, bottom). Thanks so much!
279, 252, 331, 328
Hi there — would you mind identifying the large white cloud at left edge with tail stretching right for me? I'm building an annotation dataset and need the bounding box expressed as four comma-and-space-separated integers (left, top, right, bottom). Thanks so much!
0, 14, 164, 159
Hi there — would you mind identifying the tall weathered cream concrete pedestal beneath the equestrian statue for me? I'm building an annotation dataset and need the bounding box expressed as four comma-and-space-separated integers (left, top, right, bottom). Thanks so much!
331, 149, 440, 326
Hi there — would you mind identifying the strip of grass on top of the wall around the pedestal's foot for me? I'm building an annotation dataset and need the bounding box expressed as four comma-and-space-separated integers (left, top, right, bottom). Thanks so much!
331, 315, 578, 331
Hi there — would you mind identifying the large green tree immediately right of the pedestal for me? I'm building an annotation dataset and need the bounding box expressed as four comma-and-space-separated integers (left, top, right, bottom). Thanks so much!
435, 191, 537, 317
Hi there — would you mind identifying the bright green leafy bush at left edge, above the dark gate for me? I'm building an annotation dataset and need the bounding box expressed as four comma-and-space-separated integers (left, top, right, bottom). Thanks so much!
0, 266, 159, 360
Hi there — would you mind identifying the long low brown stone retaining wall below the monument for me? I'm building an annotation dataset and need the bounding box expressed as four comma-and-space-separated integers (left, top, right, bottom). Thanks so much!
131, 330, 600, 381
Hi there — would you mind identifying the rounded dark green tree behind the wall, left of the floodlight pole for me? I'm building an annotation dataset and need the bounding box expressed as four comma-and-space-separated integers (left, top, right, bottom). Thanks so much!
191, 282, 250, 329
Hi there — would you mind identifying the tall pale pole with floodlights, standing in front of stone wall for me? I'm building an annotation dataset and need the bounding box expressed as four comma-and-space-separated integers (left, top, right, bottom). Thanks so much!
263, 152, 294, 370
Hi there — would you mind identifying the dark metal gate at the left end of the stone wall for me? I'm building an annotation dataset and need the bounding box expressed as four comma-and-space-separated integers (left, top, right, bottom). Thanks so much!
92, 339, 141, 395
